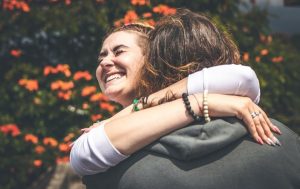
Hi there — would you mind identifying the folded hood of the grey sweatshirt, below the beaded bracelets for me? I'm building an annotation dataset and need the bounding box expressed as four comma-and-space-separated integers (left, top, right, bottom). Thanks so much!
147, 117, 248, 161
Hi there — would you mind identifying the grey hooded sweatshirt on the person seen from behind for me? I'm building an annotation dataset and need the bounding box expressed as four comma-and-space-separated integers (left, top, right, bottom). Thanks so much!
83, 118, 300, 189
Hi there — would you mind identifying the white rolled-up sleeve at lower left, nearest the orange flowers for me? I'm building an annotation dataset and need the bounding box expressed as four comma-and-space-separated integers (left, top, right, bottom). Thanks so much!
70, 124, 128, 176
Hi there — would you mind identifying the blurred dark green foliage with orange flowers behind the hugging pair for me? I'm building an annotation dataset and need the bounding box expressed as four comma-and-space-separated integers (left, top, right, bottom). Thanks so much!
0, 0, 300, 189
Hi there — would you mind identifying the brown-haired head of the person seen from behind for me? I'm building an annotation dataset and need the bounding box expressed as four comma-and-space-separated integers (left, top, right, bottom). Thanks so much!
139, 9, 240, 95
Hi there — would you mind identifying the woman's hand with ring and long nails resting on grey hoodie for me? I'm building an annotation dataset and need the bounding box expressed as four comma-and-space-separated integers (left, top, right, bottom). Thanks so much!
208, 95, 281, 146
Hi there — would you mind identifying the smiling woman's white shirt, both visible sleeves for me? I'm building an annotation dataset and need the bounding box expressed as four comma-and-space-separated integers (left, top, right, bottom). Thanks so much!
70, 64, 260, 175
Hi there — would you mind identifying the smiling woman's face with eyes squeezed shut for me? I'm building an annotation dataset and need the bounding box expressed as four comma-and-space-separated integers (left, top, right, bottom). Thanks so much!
96, 31, 144, 106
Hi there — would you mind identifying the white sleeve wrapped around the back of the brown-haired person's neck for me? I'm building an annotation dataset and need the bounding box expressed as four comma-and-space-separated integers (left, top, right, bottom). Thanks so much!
187, 64, 260, 104
